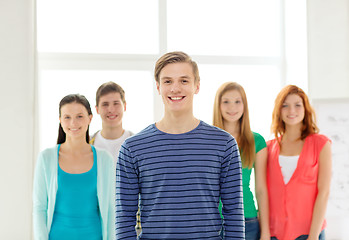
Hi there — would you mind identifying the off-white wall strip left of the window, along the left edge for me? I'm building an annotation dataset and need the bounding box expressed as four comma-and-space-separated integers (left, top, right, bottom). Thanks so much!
0, 0, 35, 240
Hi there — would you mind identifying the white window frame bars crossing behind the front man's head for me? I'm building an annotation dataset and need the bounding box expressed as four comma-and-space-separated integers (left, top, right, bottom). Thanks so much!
37, 0, 294, 146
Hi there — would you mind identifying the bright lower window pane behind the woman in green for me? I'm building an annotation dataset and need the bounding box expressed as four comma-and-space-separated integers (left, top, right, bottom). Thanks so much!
194, 65, 280, 138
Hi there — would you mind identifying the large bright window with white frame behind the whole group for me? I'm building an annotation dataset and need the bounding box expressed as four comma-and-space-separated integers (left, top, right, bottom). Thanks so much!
37, 0, 307, 150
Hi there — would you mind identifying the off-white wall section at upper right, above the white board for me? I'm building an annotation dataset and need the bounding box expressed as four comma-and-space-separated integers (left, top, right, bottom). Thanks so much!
307, 0, 349, 99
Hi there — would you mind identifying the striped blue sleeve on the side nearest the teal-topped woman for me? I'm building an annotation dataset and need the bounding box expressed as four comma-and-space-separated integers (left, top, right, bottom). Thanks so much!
115, 142, 139, 240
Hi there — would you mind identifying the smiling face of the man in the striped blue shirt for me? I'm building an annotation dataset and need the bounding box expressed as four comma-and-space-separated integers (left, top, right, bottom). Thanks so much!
156, 63, 200, 113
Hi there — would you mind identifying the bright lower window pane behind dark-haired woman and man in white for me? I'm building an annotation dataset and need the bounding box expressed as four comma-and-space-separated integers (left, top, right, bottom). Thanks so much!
39, 71, 155, 150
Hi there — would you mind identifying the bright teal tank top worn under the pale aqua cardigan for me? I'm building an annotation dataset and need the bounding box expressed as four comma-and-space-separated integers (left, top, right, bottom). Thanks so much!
49, 144, 102, 240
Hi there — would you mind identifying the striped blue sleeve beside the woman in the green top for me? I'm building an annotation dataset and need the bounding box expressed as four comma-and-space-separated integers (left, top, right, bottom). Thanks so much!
220, 138, 245, 240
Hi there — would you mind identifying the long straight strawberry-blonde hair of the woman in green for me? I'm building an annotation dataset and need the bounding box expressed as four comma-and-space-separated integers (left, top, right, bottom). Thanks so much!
213, 82, 256, 168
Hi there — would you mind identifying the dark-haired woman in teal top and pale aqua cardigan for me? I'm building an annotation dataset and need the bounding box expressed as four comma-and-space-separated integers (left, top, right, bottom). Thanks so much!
33, 94, 115, 240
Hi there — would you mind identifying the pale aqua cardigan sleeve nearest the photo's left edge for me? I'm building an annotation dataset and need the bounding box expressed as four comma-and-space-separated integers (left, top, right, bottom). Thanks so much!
33, 152, 48, 240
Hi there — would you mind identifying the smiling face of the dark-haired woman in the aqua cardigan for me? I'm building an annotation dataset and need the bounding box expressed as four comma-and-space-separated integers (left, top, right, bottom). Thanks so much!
59, 102, 92, 141
